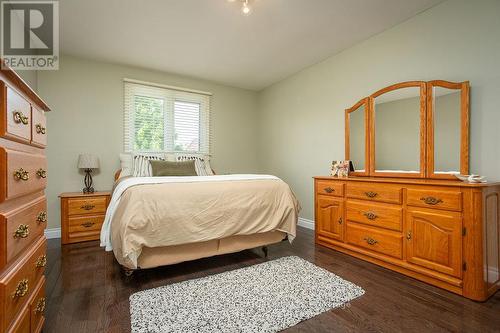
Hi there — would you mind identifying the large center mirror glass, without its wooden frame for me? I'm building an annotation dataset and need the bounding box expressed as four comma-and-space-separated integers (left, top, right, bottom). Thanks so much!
373, 85, 425, 176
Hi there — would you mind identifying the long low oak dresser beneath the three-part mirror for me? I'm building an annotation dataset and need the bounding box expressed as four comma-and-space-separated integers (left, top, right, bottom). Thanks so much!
314, 177, 500, 301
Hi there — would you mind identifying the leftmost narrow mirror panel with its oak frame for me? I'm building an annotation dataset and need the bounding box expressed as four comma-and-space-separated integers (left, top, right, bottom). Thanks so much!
345, 98, 370, 176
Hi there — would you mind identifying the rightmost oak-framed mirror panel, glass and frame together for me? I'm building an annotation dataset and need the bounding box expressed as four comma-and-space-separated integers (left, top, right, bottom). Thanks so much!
427, 81, 469, 179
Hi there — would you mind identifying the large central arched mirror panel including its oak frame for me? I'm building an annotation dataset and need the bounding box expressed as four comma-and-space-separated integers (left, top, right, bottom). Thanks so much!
369, 81, 427, 178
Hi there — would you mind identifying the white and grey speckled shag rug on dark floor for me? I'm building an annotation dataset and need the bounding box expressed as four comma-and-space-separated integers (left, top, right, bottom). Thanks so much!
130, 256, 364, 333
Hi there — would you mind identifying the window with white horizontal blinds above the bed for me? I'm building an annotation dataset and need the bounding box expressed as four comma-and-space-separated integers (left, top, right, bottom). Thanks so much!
124, 79, 210, 154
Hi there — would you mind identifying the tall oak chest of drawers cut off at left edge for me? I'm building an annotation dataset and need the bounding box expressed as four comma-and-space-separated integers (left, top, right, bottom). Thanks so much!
0, 64, 49, 332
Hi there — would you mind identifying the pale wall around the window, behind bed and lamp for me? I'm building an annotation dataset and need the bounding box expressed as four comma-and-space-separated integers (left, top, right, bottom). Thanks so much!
38, 55, 258, 228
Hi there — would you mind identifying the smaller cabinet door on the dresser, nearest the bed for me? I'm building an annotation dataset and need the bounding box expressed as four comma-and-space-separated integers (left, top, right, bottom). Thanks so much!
316, 196, 344, 240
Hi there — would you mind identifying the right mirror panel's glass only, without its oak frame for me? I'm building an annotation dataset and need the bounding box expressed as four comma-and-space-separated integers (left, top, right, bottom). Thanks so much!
432, 87, 461, 174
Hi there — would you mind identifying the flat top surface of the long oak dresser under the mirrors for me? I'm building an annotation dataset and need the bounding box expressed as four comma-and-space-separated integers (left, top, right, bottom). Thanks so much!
313, 176, 500, 187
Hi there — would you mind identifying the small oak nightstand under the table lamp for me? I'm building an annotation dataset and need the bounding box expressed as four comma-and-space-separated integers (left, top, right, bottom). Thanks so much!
59, 192, 111, 244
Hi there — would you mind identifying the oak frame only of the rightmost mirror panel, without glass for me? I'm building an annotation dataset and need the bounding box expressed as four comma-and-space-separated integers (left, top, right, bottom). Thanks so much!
427, 80, 470, 179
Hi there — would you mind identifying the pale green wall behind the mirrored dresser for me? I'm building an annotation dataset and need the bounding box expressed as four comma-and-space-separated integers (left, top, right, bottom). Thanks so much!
258, 0, 500, 220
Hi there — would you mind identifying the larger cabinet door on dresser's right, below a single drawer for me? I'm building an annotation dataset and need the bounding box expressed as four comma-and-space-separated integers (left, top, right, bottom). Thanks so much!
405, 209, 462, 277
